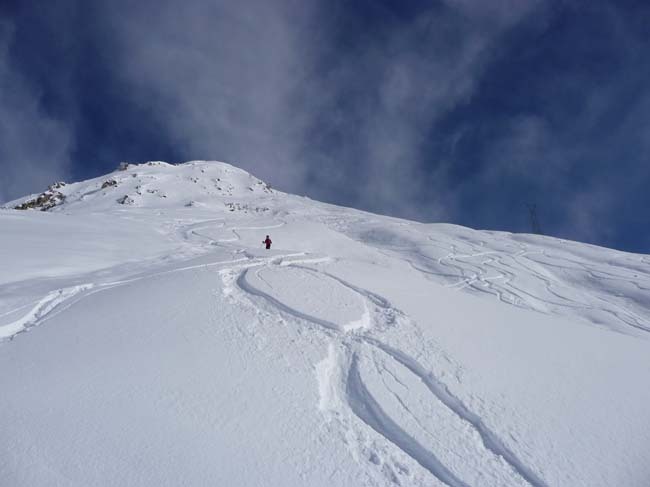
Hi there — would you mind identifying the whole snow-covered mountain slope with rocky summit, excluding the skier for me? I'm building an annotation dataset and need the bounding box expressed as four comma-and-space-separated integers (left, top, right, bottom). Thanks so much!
0, 161, 650, 487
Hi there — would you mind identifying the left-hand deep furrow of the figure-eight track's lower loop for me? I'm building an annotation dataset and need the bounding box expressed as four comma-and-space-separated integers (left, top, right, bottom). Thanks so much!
345, 354, 469, 487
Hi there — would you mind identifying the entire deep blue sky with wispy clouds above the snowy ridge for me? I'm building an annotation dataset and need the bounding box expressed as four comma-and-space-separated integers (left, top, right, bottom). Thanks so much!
0, 0, 650, 253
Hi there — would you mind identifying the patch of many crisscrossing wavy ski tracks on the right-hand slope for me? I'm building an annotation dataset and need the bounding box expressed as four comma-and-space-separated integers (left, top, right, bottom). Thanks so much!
344, 229, 650, 338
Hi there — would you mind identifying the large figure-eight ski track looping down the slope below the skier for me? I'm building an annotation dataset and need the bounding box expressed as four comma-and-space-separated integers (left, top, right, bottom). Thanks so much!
230, 258, 547, 487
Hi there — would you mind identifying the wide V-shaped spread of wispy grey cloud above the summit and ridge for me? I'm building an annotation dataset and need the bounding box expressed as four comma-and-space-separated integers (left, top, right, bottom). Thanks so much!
97, 0, 537, 218
